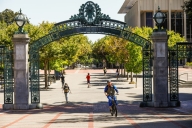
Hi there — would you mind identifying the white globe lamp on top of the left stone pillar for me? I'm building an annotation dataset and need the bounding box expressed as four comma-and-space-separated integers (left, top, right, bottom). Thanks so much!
15, 9, 26, 34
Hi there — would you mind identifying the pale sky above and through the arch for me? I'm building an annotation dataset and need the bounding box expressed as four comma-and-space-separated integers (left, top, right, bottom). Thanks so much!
0, 0, 125, 42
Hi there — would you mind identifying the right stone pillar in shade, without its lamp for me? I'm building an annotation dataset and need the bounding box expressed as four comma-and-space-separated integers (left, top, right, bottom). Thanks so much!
151, 32, 168, 107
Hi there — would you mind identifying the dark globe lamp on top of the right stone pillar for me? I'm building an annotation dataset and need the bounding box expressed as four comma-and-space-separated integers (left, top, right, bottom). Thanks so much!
153, 6, 166, 31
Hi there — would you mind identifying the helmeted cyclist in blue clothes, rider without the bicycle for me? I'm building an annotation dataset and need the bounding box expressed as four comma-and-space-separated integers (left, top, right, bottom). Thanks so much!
104, 80, 119, 111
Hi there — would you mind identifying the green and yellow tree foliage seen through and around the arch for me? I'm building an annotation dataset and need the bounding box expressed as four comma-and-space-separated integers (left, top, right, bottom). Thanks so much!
0, 8, 188, 86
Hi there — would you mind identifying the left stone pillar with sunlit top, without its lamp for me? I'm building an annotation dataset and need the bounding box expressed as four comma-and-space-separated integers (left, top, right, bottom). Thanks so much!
13, 34, 29, 109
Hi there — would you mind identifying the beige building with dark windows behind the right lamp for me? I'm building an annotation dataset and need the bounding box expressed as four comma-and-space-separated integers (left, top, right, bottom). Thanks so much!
118, 0, 192, 42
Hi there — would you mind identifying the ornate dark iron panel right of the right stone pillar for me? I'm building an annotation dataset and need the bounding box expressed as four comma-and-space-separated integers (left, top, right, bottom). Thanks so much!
169, 42, 192, 101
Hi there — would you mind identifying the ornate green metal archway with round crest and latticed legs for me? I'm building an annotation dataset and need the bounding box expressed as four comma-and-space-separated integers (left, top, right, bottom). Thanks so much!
29, 1, 152, 103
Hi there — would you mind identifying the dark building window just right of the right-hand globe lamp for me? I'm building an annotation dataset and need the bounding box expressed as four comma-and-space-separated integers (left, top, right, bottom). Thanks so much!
171, 12, 184, 36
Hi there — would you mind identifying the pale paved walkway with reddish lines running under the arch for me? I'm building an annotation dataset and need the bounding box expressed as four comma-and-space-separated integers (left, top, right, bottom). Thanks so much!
0, 69, 192, 128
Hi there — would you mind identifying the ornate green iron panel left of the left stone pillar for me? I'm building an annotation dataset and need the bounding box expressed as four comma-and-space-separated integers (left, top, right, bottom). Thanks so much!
0, 46, 13, 104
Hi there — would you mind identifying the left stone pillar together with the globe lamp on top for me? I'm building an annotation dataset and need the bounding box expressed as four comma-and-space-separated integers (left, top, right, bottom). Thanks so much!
12, 9, 30, 109
